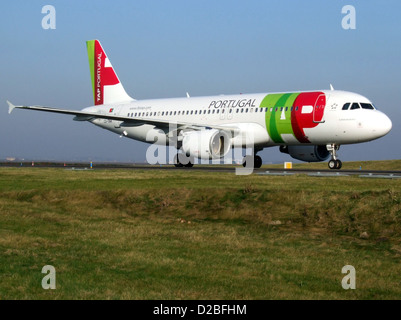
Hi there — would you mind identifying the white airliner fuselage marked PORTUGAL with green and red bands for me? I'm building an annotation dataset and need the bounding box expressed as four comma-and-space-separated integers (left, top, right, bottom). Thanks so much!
83, 90, 392, 148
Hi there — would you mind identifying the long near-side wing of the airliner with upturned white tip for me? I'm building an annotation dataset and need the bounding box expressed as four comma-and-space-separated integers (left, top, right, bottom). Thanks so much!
7, 101, 240, 135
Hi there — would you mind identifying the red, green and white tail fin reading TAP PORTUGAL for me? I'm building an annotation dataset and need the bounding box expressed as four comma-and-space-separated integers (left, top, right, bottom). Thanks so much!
86, 40, 134, 105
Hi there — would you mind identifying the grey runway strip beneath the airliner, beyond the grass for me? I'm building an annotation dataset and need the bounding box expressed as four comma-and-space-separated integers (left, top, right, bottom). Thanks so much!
0, 162, 401, 178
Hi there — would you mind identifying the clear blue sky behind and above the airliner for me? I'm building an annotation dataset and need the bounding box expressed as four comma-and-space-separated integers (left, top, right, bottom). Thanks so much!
0, 0, 401, 161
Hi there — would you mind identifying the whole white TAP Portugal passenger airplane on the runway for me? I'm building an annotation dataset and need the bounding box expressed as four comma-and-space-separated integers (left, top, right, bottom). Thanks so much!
7, 40, 392, 169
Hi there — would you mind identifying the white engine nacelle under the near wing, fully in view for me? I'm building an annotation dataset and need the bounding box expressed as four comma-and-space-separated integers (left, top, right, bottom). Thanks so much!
182, 129, 231, 159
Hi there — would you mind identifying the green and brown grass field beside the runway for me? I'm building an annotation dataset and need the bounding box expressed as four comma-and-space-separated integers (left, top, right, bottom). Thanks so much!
0, 161, 401, 299
